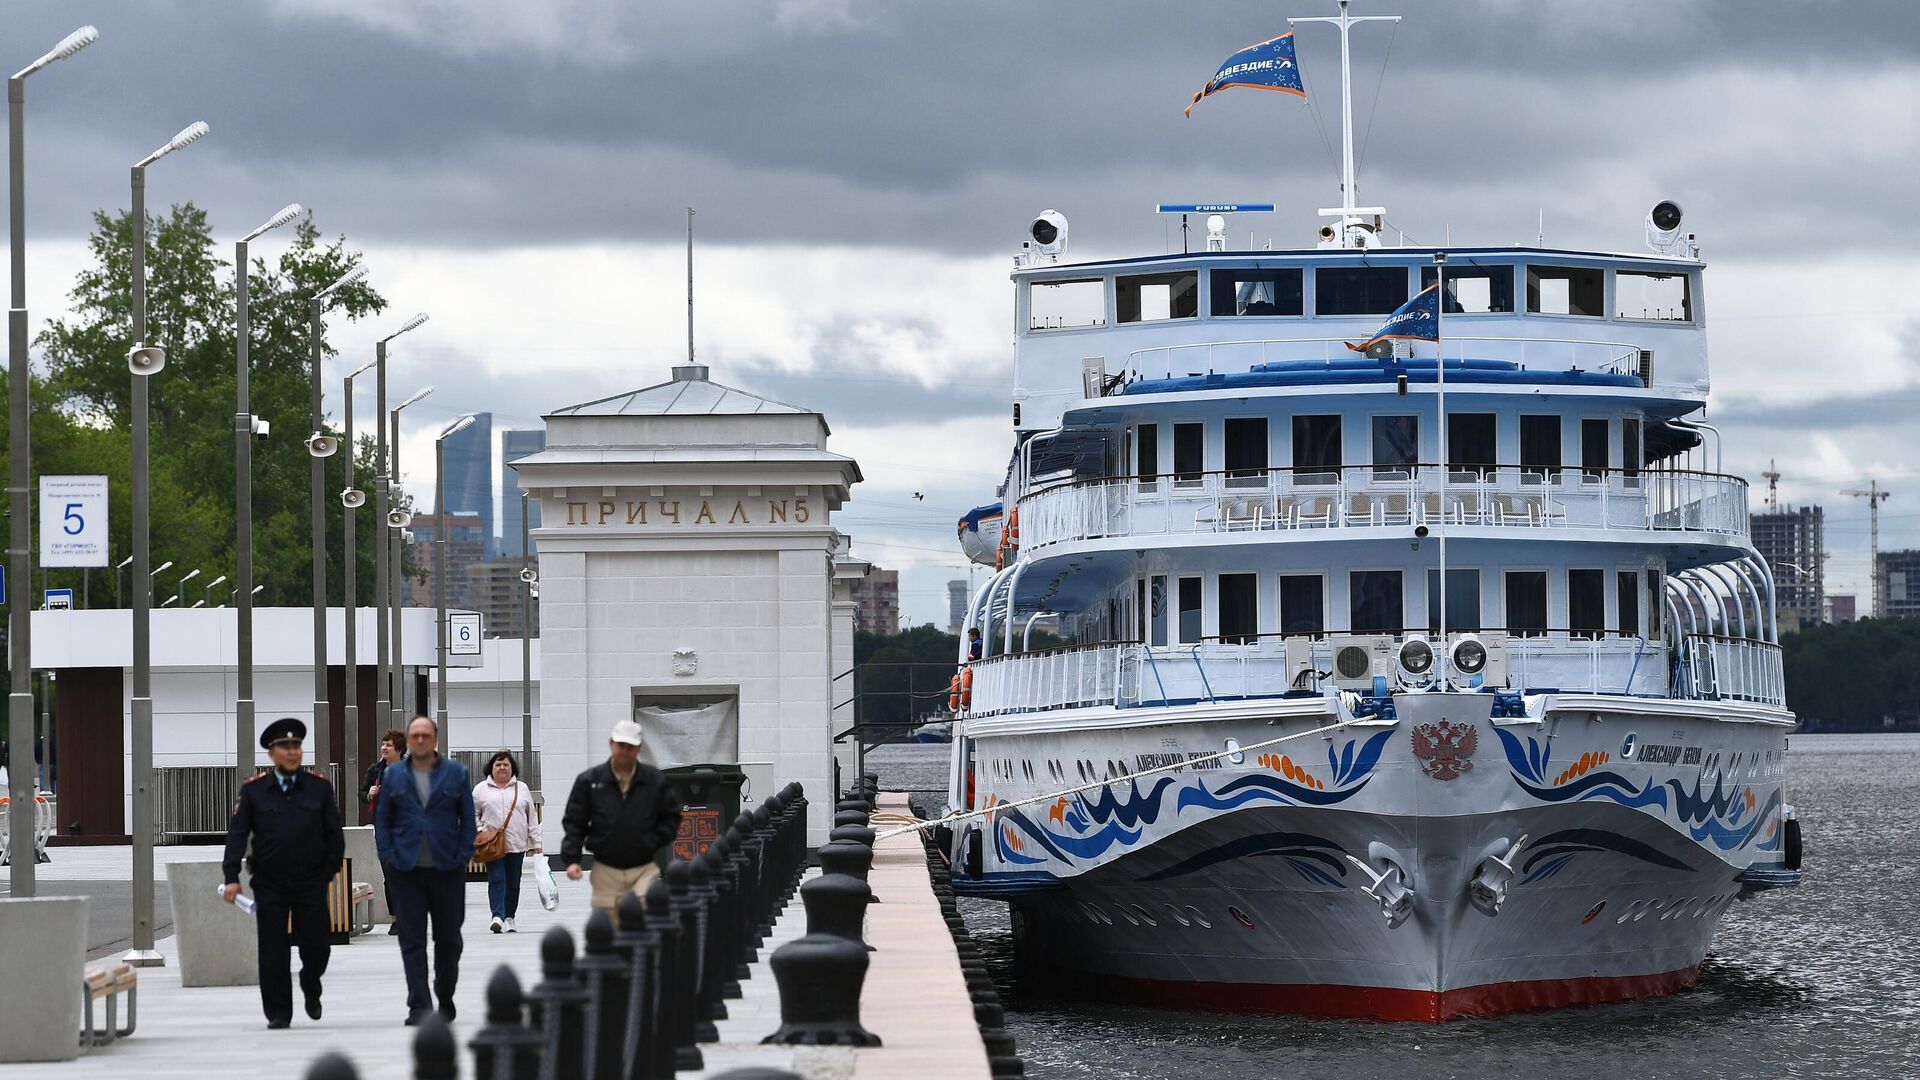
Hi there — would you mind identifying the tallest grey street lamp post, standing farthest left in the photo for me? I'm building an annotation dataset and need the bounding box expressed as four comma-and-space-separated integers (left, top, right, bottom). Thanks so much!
6, 27, 100, 897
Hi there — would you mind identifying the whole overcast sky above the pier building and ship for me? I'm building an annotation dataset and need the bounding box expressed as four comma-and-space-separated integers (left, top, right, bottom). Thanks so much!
0, 0, 1920, 625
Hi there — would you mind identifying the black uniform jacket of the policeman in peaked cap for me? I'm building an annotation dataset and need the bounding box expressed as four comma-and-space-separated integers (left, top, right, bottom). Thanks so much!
221, 769, 346, 888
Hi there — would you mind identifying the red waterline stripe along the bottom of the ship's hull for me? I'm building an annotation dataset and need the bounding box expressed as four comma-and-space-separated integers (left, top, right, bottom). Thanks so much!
1073, 965, 1699, 1022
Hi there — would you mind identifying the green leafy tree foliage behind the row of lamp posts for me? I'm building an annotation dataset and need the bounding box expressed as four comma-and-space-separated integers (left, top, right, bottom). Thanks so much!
0, 204, 397, 607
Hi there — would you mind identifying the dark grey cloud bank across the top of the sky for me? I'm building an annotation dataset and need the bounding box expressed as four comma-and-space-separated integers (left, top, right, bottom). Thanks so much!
0, 0, 1920, 252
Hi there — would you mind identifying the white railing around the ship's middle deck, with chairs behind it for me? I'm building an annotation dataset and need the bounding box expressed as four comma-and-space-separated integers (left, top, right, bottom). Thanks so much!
1020, 463, 1749, 553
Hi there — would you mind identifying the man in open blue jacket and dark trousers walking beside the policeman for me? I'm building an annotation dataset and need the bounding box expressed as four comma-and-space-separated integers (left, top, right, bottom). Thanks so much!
372, 717, 474, 1026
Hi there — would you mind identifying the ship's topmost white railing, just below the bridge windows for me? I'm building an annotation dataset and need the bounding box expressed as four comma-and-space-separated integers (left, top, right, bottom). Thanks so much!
1100, 336, 1640, 396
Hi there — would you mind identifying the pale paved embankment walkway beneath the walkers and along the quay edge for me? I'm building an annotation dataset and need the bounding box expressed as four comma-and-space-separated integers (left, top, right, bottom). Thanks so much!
18, 796, 989, 1080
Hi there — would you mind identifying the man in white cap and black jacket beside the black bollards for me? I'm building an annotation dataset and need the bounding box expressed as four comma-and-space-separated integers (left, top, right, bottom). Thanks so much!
561, 721, 680, 911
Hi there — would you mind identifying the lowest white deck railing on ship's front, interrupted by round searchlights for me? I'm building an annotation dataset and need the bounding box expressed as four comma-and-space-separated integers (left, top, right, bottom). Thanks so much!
968, 628, 1681, 717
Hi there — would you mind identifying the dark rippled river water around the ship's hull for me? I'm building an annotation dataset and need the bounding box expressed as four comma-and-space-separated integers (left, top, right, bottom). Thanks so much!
868, 734, 1920, 1080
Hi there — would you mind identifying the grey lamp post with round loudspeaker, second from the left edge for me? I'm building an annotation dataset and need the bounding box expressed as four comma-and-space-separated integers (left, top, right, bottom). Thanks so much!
123, 121, 207, 967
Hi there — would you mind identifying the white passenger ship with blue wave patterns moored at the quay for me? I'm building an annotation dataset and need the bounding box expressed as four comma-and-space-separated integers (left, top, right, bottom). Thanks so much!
936, 2, 1799, 1020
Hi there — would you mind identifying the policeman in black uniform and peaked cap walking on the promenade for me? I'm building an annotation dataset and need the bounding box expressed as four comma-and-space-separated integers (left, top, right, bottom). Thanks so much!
221, 717, 346, 1028
